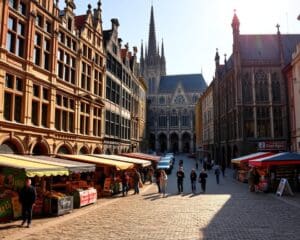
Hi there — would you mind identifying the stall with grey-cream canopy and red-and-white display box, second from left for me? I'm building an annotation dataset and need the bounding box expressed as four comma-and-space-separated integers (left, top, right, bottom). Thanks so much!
7, 156, 97, 210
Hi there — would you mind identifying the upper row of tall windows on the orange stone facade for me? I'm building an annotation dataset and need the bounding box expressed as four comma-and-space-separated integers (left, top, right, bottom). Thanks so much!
6, 5, 103, 96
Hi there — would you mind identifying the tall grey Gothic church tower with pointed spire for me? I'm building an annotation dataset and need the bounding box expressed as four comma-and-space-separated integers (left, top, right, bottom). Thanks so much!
140, 6, 166, 95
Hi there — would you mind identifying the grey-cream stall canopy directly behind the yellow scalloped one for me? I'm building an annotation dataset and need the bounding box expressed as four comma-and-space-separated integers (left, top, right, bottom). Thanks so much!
5, 155, 96, 173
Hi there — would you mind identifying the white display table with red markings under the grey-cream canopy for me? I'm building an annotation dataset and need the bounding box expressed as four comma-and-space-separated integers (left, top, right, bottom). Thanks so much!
73, 188, 97, 208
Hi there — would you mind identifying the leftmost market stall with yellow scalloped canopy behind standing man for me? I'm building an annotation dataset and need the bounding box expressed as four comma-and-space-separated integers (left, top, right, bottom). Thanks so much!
0, 154, 69, 221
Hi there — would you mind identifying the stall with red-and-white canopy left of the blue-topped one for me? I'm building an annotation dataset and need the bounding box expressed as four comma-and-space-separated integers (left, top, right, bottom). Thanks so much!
231, 152, 274, 182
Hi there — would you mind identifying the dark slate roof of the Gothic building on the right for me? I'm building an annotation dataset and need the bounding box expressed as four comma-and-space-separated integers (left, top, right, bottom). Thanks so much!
239, 34, 300, 64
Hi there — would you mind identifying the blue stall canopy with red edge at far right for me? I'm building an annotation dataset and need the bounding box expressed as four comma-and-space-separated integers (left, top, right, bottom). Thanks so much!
249, 152, 300, 167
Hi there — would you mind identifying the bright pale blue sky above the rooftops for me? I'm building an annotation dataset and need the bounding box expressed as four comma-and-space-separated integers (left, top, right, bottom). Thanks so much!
60, 0, 300, 83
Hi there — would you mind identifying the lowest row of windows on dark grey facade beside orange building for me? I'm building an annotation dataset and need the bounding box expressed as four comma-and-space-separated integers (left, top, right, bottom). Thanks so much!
105, 111, 130, 139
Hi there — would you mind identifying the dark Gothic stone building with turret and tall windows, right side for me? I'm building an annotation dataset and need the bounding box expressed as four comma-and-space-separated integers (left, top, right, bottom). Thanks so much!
213, 14, 300, 165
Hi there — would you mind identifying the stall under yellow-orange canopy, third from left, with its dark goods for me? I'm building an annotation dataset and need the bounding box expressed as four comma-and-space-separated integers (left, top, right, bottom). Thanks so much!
57, 154, 134, 196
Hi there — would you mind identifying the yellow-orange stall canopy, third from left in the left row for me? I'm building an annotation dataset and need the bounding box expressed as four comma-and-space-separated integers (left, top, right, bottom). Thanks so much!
57, 154, 133, 170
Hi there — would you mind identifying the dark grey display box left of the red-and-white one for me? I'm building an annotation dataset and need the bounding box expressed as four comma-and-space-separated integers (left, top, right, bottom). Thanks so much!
44, 196, 73, 216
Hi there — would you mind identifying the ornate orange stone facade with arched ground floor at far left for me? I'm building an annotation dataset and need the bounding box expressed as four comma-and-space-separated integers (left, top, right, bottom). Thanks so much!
0, 0, 105, 155
